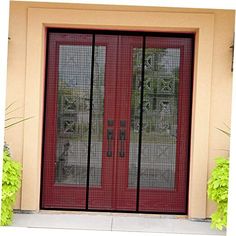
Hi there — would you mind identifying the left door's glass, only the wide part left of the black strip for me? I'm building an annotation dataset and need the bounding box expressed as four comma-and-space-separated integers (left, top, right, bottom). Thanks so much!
56, 45, 92, 186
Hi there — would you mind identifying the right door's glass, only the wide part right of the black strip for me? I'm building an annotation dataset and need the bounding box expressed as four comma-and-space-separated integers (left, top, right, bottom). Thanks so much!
140, 45, 180, 189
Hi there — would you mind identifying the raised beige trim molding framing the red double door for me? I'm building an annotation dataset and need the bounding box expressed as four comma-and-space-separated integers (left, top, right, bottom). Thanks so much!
21, 8, 214, 218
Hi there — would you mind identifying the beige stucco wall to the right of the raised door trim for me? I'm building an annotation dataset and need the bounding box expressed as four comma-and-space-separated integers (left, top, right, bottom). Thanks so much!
207, 12, 234, 216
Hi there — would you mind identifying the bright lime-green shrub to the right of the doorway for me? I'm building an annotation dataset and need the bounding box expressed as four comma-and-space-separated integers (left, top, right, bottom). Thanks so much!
208, 157, 229, 230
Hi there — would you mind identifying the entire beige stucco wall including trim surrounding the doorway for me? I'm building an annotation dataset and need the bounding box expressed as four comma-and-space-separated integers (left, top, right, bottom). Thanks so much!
6, 2, 234, 218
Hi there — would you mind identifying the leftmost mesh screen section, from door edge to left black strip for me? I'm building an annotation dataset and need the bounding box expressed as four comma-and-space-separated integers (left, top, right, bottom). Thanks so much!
42, 33, 92, 209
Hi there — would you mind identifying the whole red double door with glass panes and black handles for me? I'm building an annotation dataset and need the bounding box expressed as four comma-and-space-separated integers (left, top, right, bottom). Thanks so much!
41, 29, 193, 213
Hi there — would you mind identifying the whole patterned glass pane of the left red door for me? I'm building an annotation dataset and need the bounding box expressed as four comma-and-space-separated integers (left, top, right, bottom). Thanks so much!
56, 45, 104, 186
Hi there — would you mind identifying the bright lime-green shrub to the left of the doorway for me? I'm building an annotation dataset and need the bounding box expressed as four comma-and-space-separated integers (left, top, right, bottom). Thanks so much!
1, 146, 21, 225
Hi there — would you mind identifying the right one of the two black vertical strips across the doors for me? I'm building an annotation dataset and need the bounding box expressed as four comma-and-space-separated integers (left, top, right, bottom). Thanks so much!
136, 36, 146, 212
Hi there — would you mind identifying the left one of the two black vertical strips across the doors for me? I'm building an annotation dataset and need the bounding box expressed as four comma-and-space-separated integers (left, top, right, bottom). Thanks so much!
86, 33, 95, 210
